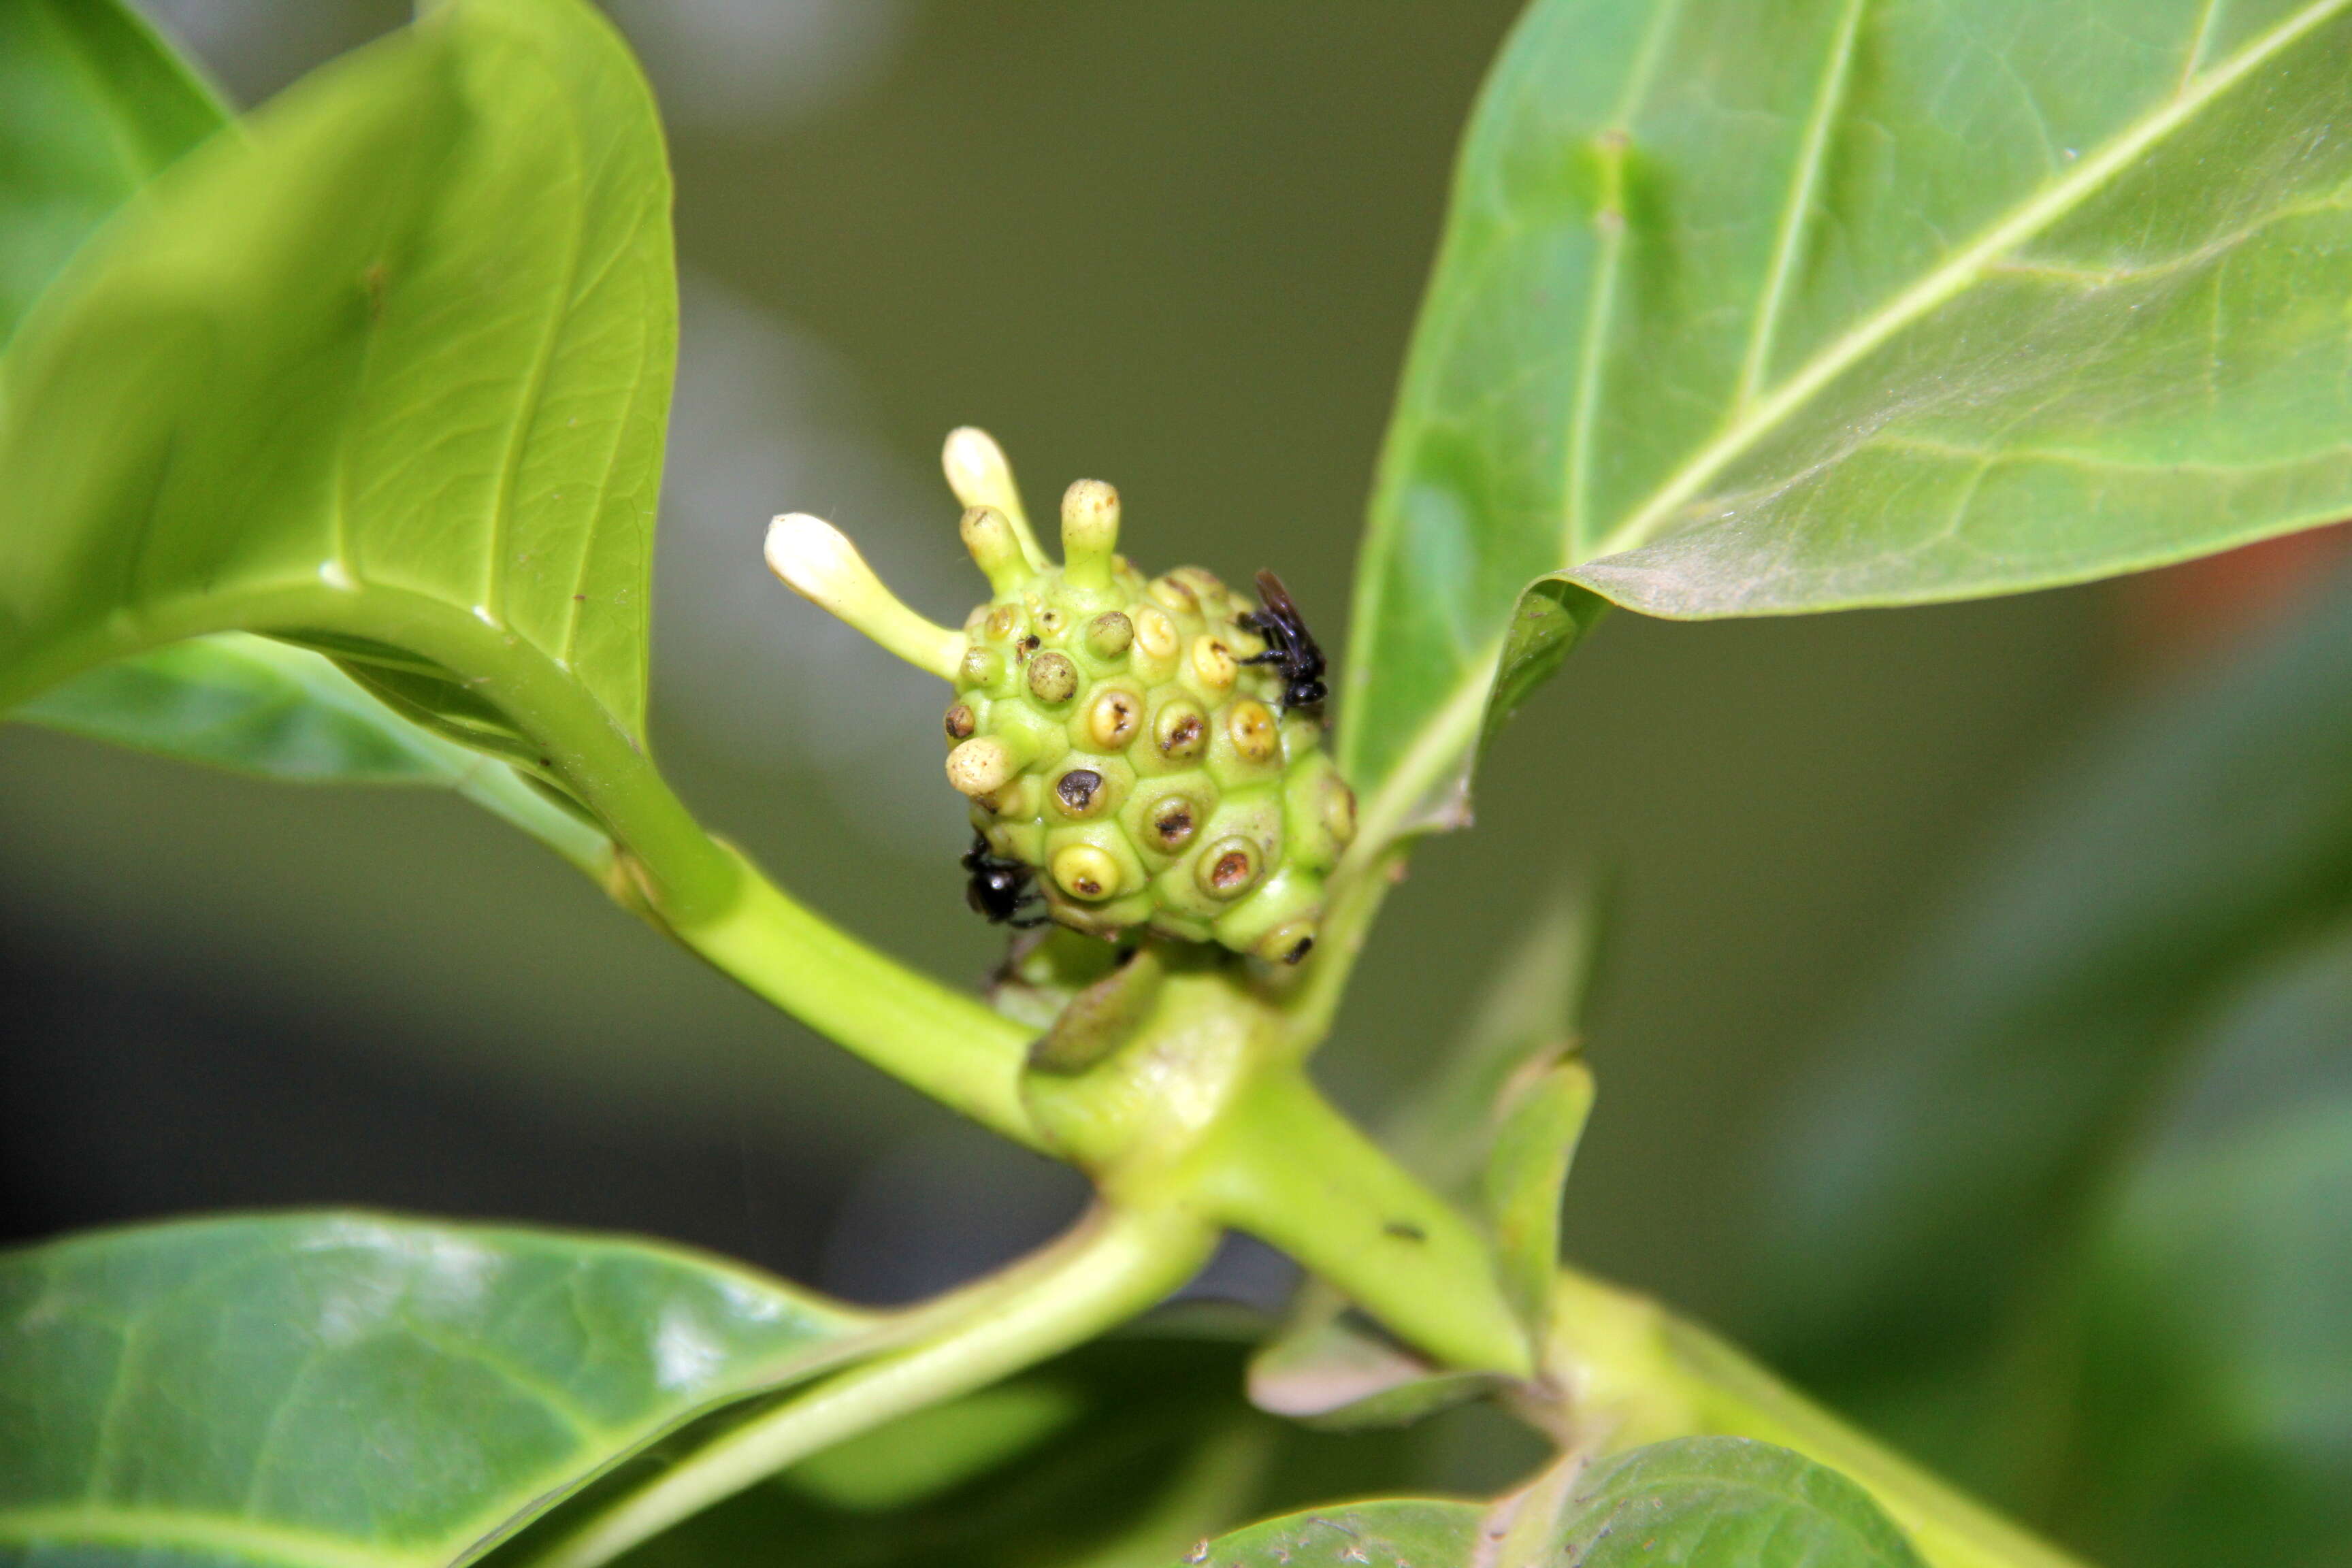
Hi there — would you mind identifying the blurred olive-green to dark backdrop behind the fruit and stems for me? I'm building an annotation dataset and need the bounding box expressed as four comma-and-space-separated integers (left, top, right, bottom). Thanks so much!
0, 0, 2145, 1330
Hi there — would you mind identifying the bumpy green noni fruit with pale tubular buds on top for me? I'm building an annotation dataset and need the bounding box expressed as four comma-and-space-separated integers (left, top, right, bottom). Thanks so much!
769, 430, 1355, 962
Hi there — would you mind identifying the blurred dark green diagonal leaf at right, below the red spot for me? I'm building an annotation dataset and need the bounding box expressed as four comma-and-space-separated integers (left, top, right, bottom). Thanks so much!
1757, 564, 2352, 1420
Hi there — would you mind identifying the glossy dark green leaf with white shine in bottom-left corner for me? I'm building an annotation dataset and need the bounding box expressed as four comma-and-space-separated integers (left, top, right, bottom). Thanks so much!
0, 1213, 872, 1568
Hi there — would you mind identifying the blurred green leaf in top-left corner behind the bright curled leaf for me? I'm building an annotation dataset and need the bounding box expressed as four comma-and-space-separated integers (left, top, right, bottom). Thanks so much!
0, 0, 228, 343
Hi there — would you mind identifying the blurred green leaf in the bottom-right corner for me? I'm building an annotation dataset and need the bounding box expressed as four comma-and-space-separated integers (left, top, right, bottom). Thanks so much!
2056, 926, 2352, 1568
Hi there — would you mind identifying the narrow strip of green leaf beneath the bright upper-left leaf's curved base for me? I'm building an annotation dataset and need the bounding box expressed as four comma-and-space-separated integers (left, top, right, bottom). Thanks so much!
10, 632, 612, 875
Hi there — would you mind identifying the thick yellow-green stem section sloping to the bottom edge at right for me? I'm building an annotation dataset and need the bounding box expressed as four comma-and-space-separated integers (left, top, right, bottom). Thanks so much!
1531, 1272, 2082, 1568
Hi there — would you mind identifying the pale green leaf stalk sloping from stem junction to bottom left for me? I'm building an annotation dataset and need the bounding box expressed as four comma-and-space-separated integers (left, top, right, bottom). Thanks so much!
534, 1206, 1218, 1568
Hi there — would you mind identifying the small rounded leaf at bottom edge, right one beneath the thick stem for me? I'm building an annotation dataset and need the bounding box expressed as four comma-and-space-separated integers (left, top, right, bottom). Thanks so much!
1550, 1437, 1922, 1568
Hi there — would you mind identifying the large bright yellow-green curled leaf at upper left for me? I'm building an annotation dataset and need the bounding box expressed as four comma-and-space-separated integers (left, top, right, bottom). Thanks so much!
0, 0, 675, 883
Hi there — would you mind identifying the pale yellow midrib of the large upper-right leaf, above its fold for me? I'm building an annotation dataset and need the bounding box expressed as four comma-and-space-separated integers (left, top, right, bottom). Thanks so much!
1569, 0, 2352, 566
